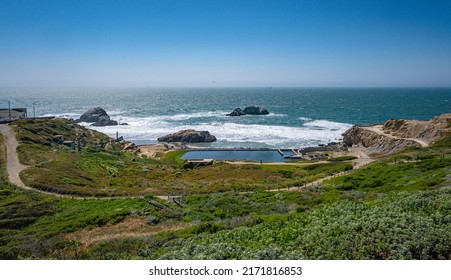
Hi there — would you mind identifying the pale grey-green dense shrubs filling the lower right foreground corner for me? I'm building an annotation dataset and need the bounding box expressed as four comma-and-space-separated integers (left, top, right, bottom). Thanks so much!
156, 188, 451, 259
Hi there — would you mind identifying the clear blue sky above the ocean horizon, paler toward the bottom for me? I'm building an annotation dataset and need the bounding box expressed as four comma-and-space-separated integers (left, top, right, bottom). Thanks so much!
0, 0, 451, 86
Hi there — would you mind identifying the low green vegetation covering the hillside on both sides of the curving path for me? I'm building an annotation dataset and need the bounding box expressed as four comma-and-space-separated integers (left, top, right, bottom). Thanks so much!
0, 117, 451, 259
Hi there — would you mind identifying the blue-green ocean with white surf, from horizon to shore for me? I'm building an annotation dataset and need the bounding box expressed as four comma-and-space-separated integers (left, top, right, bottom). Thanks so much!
0, 88, 451, 148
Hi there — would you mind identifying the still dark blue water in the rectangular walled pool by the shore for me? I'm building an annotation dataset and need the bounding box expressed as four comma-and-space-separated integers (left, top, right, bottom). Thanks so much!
182, 150, 294, 162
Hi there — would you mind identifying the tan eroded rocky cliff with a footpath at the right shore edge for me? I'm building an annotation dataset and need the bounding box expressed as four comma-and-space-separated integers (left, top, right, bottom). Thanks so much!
343, 114, 451, 155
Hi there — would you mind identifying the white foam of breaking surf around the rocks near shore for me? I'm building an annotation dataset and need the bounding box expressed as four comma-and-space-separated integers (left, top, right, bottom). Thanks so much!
86, 112, 352, 148
